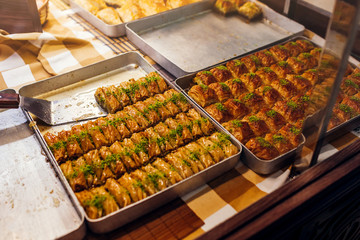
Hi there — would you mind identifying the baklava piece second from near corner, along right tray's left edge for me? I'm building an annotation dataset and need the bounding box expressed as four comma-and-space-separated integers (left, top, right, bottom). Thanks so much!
223, 119, 255, 144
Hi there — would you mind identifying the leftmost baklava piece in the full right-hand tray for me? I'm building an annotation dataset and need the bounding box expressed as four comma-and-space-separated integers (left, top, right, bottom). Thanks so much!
188, 84, 218, 107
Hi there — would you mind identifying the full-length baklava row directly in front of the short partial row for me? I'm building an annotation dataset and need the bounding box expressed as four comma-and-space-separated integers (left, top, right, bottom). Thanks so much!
44, 89, 191, 163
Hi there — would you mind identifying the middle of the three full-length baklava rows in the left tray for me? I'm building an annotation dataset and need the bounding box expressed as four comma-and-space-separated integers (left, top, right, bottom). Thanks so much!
60, 109, 215, 192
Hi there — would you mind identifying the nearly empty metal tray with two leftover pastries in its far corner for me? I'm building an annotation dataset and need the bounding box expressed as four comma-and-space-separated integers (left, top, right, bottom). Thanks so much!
126, 1, 305, 77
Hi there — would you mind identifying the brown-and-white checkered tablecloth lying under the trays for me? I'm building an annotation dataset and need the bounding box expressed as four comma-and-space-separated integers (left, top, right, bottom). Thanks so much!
0, 0, 360, 239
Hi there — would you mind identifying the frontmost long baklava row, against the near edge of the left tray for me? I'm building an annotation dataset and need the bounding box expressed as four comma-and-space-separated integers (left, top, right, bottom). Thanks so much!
75, 132, 238, 219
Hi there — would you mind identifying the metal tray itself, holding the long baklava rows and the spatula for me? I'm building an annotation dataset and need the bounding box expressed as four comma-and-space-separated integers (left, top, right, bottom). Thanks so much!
20, 52, 242, 233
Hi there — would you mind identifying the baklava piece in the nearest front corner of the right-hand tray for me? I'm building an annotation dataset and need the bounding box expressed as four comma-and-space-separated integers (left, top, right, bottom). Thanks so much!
245, 137, 280, 160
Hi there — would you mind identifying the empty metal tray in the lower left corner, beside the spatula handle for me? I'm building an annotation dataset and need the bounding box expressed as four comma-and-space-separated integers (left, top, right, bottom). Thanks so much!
0, 90, 86, 239
